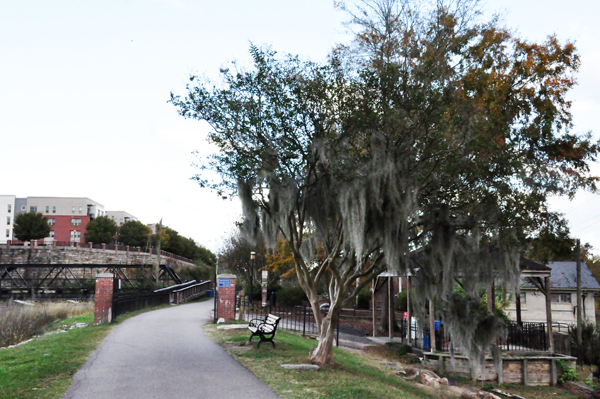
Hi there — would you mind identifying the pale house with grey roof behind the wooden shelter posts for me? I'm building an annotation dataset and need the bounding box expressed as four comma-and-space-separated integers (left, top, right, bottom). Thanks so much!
506, 261, 600, 326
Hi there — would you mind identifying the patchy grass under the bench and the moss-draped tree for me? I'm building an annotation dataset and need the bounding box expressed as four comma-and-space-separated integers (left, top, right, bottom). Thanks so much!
205, 324, 445, 399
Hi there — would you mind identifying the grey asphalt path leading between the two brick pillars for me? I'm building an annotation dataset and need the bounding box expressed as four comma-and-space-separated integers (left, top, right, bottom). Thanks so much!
64, 301, 279, 399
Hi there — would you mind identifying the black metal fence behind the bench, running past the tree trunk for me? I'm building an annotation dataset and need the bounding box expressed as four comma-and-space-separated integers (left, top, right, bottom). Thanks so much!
243, 301, 340, 346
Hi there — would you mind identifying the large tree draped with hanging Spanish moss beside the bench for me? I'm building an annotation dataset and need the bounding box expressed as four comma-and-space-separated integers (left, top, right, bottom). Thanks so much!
171, 0, 598, 364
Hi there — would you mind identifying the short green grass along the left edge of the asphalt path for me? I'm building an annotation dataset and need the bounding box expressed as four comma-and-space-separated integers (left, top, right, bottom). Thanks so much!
0, 305, 170, 399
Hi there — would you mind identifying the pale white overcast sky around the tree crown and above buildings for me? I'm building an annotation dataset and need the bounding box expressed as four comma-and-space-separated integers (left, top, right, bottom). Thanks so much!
0, 0, 600, 253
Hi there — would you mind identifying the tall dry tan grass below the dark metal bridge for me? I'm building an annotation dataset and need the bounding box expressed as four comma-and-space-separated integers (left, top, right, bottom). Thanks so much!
0, 302, 94, 348
